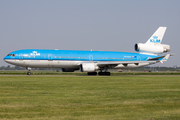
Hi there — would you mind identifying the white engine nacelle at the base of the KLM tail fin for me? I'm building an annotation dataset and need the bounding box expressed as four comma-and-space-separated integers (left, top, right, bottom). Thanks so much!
135, 43, 170, 54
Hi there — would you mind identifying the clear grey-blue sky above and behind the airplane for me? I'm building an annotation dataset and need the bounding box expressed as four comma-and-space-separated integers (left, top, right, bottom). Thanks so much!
0, 0, 180, 67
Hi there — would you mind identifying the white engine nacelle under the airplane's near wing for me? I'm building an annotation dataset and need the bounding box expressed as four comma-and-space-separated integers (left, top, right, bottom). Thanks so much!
81, 63, 99, 72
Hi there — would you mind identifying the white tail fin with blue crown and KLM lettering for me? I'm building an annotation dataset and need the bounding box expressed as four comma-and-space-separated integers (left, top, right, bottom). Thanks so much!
145, 27, 167, 44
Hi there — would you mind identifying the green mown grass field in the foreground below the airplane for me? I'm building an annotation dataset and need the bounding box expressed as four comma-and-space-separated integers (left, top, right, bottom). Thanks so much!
0, 75, 180, 120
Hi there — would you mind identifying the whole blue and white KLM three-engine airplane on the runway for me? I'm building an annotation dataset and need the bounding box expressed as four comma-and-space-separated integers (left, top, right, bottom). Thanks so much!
4, 27, 172, 75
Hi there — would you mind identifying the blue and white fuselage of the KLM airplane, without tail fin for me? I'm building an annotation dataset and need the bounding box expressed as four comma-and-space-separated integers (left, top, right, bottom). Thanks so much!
4, 49, 159, 69
